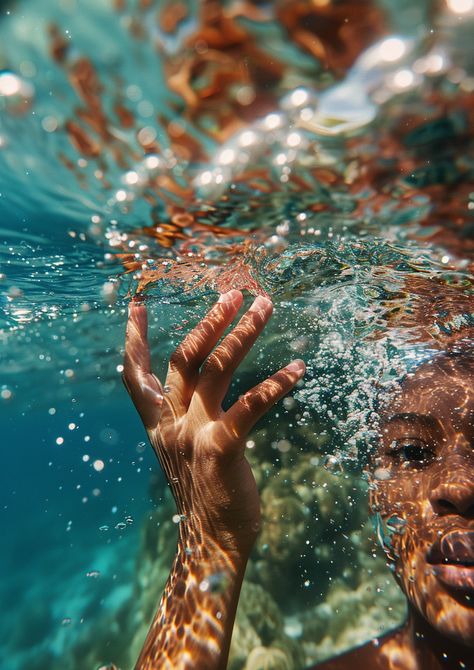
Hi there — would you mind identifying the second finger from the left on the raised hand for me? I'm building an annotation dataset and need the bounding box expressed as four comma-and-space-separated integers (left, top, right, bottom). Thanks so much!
165, 290, 243, 410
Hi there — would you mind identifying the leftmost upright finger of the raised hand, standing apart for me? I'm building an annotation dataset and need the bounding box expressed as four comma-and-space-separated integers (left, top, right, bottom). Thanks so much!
122, 301, 163, 428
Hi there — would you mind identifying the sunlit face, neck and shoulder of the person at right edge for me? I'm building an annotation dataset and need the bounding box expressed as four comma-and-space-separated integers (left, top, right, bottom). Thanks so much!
317, 353, 474, 670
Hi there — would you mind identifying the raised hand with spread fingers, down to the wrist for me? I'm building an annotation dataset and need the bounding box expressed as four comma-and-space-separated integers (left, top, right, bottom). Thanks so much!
123, 290, 305, 551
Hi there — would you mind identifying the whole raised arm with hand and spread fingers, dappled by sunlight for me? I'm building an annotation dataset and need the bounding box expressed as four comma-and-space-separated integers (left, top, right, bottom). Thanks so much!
124, 290, 305, 670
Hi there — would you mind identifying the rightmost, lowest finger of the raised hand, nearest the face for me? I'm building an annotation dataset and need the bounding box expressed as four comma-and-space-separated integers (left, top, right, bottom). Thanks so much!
223, 359, 306, 442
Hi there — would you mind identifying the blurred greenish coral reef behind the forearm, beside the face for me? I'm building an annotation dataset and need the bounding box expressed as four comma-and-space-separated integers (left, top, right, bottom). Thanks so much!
66, 414, 404, 670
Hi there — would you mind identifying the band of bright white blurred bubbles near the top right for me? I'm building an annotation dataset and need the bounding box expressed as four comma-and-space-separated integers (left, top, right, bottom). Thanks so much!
195, 35, 450, 199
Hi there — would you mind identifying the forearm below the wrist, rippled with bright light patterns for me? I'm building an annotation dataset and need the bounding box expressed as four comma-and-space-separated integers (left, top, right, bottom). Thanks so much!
135, 519, 252, 670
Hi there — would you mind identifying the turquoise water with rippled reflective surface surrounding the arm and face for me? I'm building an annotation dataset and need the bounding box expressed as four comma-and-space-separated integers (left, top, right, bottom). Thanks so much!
0, 0, 474, 670
